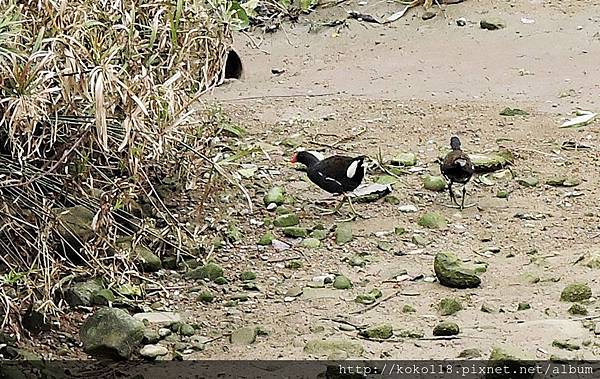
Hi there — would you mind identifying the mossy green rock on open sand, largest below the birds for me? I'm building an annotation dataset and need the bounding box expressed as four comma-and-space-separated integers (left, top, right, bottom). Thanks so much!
433, 252, 481, 288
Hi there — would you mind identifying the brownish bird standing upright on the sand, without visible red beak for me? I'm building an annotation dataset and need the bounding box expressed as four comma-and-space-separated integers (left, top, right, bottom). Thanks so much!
440, 137, 475, 209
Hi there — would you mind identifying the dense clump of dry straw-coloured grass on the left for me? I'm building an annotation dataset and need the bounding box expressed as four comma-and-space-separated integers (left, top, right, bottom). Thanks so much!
0, 0, 237, 338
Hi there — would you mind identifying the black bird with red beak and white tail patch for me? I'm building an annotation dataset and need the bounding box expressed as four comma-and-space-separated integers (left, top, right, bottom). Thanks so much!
292, 151, 366, 218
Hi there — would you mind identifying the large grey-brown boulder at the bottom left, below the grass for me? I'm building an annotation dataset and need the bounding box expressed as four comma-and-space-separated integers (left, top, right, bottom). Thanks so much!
79, 308, 145, 359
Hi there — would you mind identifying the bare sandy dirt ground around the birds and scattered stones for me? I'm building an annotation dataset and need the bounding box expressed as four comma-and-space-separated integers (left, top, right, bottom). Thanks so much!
18, 0, 600, 359
